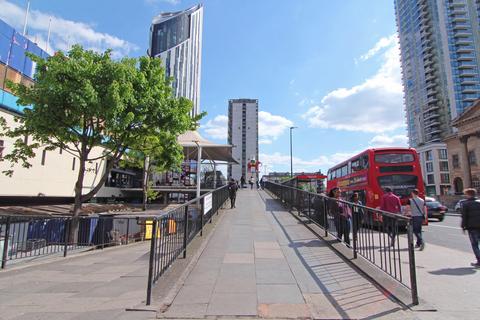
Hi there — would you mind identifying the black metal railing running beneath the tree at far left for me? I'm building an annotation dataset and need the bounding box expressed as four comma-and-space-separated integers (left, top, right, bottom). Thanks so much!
0, 215, 144, 269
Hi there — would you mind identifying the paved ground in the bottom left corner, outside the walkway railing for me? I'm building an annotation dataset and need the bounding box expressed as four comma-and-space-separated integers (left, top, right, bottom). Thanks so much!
0, 243, 155, 320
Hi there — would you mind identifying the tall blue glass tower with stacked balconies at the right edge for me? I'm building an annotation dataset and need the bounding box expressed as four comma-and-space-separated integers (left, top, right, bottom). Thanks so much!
395, 0, 480, 195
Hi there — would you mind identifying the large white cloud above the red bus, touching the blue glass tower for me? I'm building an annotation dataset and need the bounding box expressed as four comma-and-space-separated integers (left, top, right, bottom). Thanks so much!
302, 37, 405, 133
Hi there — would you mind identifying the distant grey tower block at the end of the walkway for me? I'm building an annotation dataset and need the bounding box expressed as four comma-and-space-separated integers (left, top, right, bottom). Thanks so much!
228, 99, 258, 181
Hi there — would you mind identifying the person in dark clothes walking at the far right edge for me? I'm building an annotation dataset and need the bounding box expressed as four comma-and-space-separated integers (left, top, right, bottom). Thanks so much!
462, 189, 480, 268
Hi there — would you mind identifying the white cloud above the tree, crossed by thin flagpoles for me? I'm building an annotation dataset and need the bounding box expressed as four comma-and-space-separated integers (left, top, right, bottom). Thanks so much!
0, 0, 138, 58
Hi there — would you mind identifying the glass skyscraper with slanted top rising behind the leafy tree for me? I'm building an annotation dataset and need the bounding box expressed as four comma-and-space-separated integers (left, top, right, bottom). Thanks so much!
149, 4, 203, 115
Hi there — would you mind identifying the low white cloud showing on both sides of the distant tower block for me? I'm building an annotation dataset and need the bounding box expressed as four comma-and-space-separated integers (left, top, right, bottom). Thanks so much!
202, 111, 293, 144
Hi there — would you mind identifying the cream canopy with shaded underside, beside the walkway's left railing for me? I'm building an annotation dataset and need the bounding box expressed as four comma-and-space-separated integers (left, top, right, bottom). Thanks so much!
177, 131, 238, 164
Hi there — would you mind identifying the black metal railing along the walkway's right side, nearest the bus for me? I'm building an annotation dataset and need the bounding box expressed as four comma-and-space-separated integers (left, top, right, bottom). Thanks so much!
265, 182, 418, 305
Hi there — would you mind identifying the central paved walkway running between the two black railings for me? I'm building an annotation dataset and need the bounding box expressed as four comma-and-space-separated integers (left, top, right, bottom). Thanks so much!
158, 190, 413, 319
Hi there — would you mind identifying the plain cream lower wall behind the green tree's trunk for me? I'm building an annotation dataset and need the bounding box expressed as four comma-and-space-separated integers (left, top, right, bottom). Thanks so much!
0, 110, 121, 197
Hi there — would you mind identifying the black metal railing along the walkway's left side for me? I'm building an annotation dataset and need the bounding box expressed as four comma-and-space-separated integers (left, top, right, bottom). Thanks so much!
146, 186, 229, 305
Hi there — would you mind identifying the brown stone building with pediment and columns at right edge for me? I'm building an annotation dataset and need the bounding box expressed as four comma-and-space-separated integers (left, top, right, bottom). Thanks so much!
445, 100, 480, 194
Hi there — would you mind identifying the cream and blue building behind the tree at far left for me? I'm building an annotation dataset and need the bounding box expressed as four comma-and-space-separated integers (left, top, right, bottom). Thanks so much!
0, 20, 125, 203
